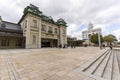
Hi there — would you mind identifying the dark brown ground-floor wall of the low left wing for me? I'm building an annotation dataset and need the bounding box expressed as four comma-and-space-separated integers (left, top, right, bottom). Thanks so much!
0, 36, 25, 49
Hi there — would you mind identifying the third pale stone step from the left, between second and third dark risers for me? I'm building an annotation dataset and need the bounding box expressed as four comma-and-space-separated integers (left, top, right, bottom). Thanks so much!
93, 51, 111, 77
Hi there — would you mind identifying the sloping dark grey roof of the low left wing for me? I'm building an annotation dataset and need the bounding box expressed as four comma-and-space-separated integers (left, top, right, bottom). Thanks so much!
0, 21, 22, 31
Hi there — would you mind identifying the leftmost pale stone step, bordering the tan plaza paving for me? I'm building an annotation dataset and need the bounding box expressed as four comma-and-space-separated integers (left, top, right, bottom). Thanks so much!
81, 50, 109, 72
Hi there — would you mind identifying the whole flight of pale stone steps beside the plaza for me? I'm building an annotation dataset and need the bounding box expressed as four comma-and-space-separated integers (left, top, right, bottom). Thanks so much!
81, 50, 120, 80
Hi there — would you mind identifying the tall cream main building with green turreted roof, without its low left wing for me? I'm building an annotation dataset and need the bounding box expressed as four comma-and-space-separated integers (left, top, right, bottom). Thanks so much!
0, 4, 67, 48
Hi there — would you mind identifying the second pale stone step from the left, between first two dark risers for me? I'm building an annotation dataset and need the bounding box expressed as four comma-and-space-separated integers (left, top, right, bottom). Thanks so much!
85, 49, 109, 74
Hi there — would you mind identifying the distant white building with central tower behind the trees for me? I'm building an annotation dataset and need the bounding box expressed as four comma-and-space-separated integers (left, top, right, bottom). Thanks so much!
82, 22, 102, 43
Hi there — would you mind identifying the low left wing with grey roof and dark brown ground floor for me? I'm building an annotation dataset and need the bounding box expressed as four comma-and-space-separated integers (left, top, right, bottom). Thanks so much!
0, 17, 25, 49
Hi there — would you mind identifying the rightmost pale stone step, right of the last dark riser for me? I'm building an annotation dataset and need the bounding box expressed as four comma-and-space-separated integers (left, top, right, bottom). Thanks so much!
112, 51, 120, 80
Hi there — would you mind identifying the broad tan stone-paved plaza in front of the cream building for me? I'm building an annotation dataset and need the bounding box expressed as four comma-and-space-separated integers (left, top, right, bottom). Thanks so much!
0, 47, 103, 80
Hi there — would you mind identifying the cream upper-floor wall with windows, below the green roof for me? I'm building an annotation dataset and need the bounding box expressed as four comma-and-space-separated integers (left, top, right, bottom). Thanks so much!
20, 14, 66, 38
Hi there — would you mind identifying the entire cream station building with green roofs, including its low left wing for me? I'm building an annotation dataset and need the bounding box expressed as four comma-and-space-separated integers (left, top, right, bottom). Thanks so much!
0, 4, 67, 48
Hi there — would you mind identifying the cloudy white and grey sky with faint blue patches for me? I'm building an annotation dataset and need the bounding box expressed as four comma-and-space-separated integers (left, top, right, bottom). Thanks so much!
0, 0, 120, 41
